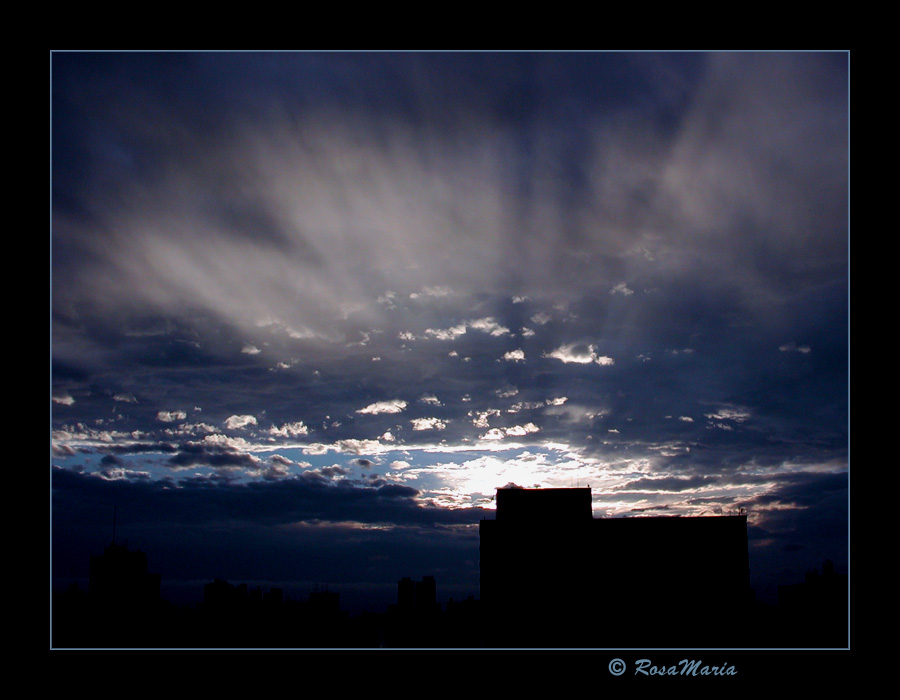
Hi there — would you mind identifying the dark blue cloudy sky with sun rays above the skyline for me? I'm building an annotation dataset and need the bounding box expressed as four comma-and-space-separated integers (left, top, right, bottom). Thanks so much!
50, 52, 850, 611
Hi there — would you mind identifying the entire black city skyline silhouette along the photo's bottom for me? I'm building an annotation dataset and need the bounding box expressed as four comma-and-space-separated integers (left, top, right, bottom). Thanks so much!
51, 488, 849, 649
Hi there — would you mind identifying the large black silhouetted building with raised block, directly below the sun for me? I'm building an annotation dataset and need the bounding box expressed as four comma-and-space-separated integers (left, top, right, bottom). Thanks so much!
480, 488, 750, 646
